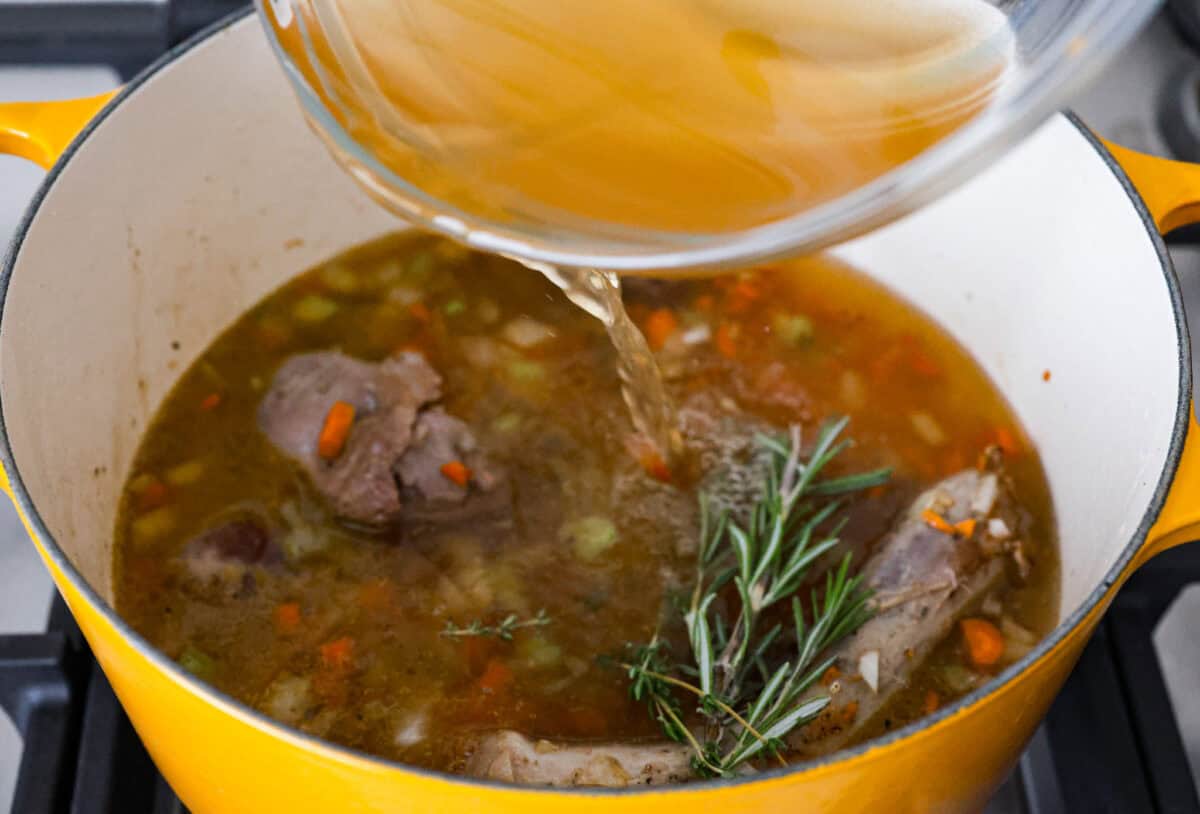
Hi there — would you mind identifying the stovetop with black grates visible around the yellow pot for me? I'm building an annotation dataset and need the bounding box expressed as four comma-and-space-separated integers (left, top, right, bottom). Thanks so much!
0, 0, 1200, 814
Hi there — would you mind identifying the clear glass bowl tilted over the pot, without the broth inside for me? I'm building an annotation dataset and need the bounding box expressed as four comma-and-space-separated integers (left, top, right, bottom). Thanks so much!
257, 0, 1159, 274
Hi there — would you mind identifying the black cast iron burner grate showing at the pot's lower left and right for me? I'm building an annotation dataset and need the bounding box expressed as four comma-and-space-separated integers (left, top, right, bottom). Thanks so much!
0, 545, 1200, 814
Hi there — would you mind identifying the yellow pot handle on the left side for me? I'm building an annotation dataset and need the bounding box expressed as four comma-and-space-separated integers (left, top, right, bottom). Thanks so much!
0, 90, 116, 169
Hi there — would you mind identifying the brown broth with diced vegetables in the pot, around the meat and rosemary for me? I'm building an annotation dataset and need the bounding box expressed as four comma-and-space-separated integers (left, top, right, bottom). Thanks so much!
115, 238, 1058, 771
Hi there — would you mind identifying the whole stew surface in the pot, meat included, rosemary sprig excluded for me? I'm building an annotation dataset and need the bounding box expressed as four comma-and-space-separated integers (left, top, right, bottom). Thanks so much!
115, 237, 1058, 785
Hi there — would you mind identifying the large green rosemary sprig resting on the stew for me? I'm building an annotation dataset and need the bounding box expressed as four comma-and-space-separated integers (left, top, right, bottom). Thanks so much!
624, 418, 889, 776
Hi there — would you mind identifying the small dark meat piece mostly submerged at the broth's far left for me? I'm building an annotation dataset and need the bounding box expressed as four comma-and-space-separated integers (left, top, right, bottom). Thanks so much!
184, 519, 283, 593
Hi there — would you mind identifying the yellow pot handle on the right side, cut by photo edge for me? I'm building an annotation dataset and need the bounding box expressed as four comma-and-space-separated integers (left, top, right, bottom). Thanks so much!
1104, 136, 1200, 564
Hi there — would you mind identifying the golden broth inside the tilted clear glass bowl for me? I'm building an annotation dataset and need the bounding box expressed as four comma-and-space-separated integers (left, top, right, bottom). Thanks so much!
272, 0, 1013, 233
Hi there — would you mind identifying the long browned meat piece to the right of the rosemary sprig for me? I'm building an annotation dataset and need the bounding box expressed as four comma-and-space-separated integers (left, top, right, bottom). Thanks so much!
788, 469, 1016, 755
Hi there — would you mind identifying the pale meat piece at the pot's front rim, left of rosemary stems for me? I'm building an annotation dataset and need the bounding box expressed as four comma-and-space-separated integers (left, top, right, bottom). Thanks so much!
466, 730, 691, 789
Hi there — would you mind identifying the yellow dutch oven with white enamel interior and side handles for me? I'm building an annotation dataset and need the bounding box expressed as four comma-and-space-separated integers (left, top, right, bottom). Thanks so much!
0, 7, 1200, 814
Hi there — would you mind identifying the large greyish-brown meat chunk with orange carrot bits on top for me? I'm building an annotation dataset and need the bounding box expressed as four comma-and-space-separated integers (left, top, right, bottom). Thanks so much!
258, 352, 497, 526
